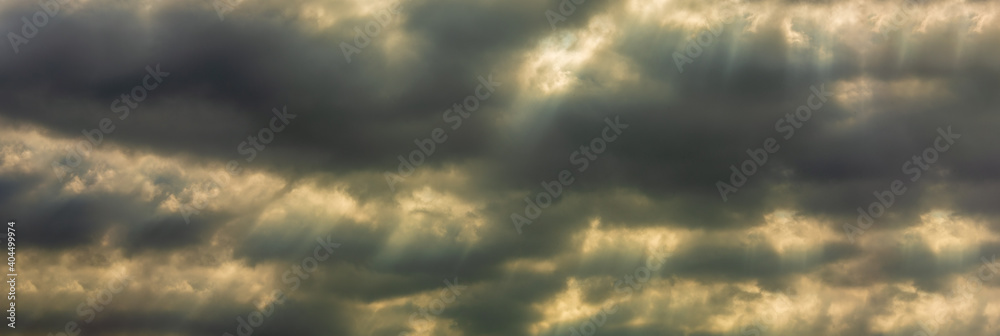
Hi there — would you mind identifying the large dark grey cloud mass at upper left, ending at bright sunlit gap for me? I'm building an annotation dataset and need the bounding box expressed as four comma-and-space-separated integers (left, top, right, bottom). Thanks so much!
0, 2, 544, 175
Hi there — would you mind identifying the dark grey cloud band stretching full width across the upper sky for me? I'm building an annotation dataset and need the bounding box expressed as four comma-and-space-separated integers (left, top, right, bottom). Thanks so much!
3, 2, 996, 225
